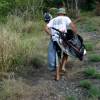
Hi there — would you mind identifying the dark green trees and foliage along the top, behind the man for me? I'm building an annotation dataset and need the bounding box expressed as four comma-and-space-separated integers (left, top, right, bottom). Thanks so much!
0, 0, 96, 19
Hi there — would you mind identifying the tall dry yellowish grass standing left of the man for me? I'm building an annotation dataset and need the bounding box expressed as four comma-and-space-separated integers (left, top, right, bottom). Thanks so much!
0, 16, 47, 72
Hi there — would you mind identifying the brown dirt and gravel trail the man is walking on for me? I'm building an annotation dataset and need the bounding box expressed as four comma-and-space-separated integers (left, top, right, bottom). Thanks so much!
20, 32, 100, 100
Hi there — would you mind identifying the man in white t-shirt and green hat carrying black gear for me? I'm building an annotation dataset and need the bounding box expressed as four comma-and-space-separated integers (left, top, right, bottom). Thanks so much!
45, 8, 77, 80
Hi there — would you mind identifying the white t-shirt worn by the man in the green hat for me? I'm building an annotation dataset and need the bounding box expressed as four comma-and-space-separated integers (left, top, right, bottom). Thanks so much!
47, 16, 71, 41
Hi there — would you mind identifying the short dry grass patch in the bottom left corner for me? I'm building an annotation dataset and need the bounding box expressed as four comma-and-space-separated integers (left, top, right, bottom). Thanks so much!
0, 79, 34, 100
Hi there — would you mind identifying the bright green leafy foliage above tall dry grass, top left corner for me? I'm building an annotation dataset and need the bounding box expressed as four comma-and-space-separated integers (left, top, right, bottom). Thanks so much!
0, 0, 44, 19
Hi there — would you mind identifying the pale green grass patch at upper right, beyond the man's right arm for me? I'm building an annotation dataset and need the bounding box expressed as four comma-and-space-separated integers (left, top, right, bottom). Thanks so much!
78, 13, 100, 32
